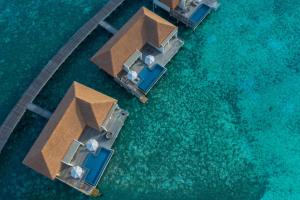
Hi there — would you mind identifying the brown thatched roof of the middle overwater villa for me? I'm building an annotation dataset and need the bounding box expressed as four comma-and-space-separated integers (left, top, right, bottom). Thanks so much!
91, 8, 177, 76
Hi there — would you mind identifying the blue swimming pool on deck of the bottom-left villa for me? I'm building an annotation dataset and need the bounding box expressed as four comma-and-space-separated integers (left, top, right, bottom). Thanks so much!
84, 147, 113, 186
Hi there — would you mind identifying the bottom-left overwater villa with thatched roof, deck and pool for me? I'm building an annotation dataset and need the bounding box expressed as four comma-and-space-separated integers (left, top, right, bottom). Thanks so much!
23, 82, 128, 195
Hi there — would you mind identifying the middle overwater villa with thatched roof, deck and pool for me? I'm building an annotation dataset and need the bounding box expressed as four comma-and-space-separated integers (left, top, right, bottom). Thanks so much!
91, 8, 183, 103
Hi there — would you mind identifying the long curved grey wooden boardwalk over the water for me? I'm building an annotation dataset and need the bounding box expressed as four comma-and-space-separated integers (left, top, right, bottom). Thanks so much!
0, 0, 125, 152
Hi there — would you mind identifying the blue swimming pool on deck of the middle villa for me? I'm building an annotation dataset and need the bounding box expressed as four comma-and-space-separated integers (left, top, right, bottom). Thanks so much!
138, 64, 167, 94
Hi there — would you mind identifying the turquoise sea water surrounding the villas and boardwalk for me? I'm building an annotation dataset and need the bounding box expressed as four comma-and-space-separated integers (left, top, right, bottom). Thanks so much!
0, 0, 300, 200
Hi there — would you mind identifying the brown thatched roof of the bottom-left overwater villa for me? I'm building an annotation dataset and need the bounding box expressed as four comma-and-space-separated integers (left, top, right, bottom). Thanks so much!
23, 82, 117, 179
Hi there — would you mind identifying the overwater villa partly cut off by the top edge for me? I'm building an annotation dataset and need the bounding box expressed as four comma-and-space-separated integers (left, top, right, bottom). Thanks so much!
153, 0, 219, 29
